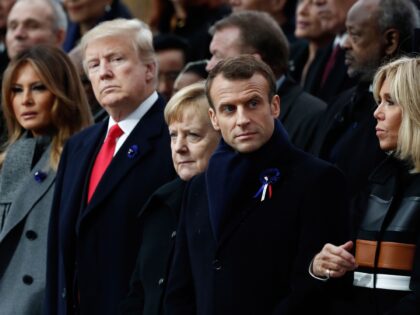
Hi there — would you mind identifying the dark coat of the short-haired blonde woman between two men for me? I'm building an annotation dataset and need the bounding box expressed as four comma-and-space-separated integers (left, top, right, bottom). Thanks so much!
121, 178, 186, 315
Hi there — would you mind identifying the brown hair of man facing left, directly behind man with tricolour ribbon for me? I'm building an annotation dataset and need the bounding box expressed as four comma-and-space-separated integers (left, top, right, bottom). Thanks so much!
210, 11, 289, 77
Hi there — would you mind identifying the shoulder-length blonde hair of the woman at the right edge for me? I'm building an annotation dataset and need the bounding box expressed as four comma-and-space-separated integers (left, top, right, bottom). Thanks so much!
373, 57, 420, 173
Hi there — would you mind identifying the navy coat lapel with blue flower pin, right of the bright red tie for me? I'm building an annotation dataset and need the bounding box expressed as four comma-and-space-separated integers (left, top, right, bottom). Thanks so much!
78, 101, 163, 226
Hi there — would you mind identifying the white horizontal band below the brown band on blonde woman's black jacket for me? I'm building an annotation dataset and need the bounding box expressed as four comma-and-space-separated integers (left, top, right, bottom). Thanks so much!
353, 271, 411, 291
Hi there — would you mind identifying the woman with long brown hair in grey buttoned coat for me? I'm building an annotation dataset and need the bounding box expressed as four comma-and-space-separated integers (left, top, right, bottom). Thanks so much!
0, 46, 92, 315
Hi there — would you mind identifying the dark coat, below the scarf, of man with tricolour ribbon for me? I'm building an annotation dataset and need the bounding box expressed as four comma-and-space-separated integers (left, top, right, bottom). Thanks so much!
165, 141, 348, 315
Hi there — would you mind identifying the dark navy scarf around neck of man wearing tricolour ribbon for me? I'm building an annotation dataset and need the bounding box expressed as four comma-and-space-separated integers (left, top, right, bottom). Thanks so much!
205, 119, 291, 238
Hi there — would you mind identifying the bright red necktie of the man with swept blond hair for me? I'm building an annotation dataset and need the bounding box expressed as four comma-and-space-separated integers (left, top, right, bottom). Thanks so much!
88, 124, 124, 202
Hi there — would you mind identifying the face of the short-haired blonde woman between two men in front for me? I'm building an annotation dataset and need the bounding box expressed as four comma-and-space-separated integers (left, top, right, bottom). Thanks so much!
169, 107, 220, 180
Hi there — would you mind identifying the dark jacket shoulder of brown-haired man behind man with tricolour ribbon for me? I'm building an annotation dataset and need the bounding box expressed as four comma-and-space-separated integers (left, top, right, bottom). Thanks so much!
277, 76, 327, 150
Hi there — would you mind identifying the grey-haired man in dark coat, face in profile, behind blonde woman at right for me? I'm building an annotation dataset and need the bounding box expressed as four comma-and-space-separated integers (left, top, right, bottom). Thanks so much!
311, 0, 419, 197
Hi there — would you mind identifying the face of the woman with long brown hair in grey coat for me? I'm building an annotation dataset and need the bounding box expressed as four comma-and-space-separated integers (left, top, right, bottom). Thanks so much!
11, 62, 55, 137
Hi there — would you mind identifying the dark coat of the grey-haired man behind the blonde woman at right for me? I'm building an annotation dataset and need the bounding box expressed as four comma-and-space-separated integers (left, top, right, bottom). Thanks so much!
311, 84, 385, 196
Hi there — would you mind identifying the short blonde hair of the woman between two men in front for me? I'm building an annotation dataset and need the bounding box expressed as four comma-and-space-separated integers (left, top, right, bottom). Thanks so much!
164, 81, 211, 126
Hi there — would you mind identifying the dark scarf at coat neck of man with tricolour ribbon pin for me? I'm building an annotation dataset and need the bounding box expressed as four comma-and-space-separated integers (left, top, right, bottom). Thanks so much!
205, 121, 295, 245
